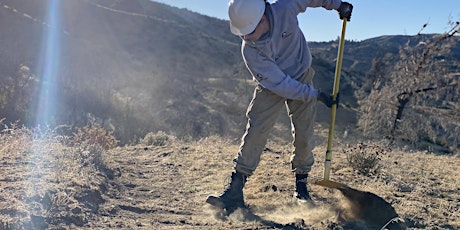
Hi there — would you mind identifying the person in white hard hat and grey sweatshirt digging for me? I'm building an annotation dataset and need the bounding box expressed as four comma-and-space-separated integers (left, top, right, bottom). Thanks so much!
206, 0, 353, 213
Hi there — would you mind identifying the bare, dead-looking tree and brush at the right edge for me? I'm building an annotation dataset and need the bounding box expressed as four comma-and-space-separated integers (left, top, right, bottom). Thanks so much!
357, 21, 460, 154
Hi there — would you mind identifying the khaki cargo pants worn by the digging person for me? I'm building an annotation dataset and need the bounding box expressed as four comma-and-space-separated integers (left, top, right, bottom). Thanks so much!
234, 68, 316, 176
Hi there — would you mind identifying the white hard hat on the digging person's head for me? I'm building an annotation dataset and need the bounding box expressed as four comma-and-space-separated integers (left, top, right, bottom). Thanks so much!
228, 0, 265, 36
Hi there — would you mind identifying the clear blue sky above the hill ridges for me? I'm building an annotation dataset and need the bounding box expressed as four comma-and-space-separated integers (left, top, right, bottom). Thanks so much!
154, 0, 460, 41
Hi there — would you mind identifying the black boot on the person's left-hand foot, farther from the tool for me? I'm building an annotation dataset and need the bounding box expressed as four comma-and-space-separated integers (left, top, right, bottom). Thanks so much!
206, 172, 247, 214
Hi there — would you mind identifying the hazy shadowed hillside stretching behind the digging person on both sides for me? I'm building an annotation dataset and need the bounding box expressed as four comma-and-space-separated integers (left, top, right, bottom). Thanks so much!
0, 0, 460, 147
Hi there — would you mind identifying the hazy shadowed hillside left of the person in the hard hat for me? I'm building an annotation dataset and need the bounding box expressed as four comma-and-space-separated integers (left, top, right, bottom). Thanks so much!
0, 0, 247, 140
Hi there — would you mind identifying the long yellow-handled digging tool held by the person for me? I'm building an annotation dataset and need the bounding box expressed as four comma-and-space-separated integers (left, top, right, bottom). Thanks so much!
314, 18, 347, 188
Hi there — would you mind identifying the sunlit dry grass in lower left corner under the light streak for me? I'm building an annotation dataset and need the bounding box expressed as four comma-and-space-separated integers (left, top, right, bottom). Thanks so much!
0, 122, 114, 229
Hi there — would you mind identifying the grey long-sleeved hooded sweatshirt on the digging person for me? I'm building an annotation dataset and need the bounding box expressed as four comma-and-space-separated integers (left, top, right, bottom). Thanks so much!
241, 0, 341, 101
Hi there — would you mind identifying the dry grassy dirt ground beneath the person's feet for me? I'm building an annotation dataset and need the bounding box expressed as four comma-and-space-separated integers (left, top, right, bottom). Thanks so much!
0, 126, 460, 229
